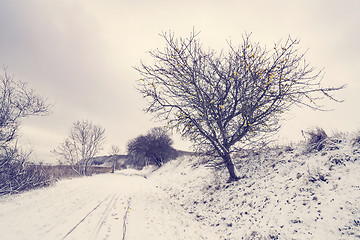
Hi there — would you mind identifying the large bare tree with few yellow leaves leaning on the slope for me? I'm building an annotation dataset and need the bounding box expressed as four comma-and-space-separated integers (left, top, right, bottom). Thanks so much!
135, 32, 344, 180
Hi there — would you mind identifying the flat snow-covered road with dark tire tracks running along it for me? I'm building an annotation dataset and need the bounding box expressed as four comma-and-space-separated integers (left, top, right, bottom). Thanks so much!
0, 173, 218, 240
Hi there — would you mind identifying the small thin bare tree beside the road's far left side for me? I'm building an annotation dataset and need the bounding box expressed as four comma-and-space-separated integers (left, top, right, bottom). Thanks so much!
53, 120, 105, 175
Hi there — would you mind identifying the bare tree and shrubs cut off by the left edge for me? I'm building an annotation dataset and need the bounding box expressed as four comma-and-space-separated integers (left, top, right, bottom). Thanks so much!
0, 67, 50, 195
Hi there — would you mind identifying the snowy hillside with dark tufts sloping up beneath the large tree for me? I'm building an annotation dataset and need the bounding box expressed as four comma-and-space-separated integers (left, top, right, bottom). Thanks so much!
151, 132, 360, 239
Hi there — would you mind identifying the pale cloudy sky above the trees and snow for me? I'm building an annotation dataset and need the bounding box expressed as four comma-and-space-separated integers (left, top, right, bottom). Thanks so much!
0, 0, 360, 162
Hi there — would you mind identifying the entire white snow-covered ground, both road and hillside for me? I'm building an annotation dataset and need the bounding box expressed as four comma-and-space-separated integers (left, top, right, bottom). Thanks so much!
0, 134, 360, 240
